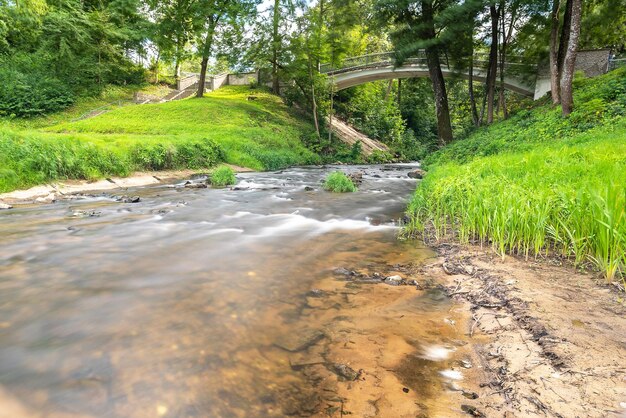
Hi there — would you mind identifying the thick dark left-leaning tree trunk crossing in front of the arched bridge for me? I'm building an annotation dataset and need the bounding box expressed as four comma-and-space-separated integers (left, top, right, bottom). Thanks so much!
422, 0, 452, 146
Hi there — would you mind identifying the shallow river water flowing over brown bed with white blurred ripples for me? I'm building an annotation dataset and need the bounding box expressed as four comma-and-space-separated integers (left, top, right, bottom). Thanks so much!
0, 165, 476, 418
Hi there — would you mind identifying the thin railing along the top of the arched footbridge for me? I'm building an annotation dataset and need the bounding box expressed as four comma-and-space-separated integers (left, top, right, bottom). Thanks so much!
320, 50, 537, 80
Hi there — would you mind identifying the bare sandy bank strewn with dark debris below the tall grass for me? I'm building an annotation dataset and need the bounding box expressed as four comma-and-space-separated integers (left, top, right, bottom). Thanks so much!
423, 245, 626, 418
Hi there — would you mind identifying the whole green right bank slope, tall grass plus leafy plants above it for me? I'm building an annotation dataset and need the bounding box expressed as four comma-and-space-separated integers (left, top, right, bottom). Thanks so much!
409, 69, 626, 280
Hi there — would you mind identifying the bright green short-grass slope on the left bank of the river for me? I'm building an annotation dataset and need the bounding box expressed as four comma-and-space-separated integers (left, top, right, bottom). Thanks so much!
0, 87, 318, 191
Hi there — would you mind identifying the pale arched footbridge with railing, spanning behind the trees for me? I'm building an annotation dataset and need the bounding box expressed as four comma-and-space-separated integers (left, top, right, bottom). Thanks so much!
320, 51, 537, 97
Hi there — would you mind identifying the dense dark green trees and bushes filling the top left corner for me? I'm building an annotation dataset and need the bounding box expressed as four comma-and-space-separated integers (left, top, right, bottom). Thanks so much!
0, 0, 147, 117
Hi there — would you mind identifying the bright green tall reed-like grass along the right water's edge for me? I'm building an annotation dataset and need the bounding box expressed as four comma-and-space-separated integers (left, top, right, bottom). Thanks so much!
407, 131, 626, 281
